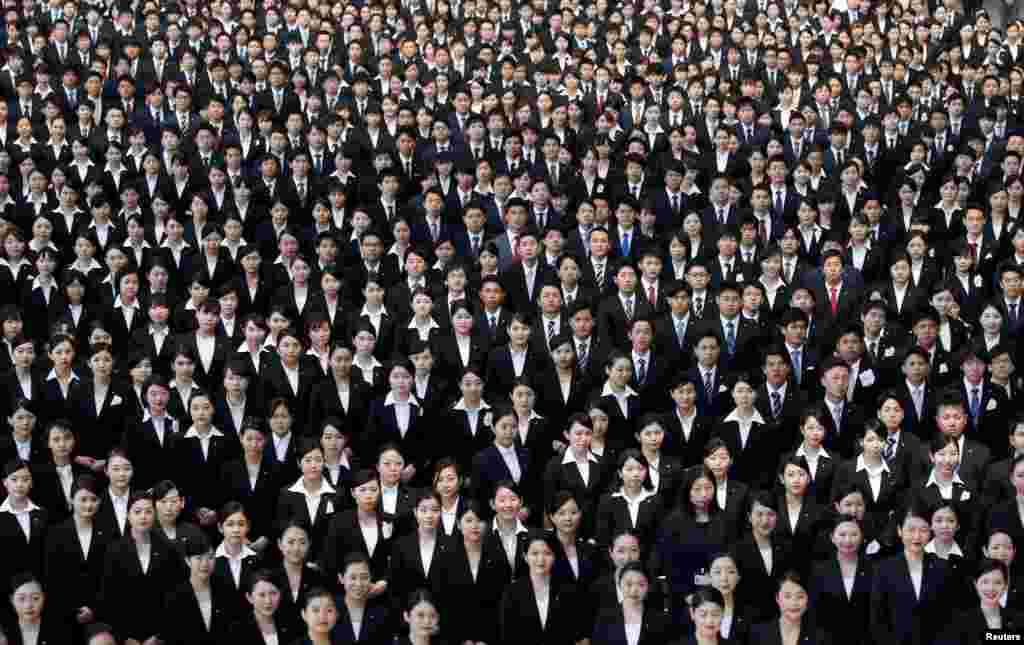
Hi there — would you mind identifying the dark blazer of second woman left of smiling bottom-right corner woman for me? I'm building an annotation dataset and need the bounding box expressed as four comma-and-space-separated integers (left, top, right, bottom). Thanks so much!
810, 557, 872, 645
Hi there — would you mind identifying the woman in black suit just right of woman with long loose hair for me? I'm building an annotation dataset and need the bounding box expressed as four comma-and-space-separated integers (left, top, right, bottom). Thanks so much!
732, 490, 796, 621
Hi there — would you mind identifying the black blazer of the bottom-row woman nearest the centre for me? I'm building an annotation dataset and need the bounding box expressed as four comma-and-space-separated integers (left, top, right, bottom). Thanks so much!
498, 576, 587, 645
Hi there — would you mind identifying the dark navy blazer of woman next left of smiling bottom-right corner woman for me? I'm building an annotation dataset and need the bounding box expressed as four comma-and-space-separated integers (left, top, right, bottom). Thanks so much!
870, 554, 953, 645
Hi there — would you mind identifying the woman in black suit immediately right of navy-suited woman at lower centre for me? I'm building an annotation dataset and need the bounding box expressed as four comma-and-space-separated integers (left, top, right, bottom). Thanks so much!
544, 413, 606, 538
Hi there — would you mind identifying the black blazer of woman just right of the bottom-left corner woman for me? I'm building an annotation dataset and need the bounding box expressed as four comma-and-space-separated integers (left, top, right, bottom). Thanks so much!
45, 518, 114, 621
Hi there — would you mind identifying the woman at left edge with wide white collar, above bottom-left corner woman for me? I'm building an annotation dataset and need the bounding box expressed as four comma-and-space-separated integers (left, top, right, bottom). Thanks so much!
0, 459, 49, 579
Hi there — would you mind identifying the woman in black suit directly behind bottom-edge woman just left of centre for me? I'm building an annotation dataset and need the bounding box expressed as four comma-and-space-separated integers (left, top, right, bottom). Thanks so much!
388, 489, 449, 610
